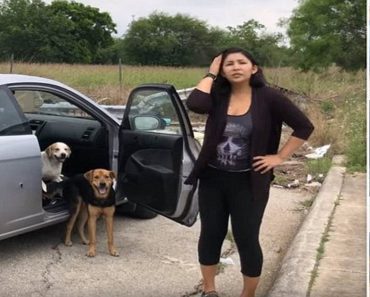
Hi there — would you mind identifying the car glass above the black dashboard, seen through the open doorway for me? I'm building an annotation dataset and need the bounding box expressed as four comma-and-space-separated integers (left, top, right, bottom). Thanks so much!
13, 90, 91, 118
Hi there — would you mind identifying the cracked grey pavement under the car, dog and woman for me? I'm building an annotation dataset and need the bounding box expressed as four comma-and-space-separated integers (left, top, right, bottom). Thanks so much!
0, 188, 312, 297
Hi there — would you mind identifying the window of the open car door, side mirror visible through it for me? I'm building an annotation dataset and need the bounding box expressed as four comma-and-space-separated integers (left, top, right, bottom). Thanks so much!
129, 90, 181, 134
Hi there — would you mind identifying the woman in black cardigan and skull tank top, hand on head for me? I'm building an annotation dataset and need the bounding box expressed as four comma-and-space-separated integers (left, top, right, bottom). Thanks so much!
186, 48, 314, 297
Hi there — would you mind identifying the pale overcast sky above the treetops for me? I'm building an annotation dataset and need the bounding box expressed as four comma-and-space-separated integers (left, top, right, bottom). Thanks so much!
45, 0, 298, 36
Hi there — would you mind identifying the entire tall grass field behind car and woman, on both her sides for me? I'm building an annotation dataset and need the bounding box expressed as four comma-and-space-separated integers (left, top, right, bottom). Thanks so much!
0, 63, 366, 171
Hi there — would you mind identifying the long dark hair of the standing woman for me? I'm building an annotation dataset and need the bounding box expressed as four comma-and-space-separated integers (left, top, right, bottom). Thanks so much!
212, 47, 266, 100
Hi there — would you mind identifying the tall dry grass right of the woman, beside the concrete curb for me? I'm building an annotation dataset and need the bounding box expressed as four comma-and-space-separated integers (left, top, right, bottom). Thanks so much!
266, 67, 367, 172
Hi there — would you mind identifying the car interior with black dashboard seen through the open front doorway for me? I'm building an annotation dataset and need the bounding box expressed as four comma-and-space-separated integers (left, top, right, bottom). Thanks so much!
13, 89, 110, 211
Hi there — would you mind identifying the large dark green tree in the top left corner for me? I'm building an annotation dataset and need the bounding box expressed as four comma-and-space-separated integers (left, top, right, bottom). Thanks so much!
0, 0, 115, 63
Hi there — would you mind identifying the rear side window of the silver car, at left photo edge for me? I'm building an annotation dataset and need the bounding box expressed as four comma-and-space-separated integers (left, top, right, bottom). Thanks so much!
0, 88, 32, 136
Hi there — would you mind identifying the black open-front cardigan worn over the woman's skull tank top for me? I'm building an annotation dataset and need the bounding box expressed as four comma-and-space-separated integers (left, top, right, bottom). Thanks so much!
185, 86, 314, 199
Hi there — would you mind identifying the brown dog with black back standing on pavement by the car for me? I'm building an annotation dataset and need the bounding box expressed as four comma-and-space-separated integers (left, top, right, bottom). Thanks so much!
63, 169, 119, 257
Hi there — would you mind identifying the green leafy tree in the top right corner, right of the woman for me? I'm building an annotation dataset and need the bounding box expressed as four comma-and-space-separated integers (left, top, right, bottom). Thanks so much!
287, 0, 366, 70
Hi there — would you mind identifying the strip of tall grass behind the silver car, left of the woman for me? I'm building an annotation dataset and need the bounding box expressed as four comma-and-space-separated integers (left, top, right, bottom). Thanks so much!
0, 63, 205, 104
